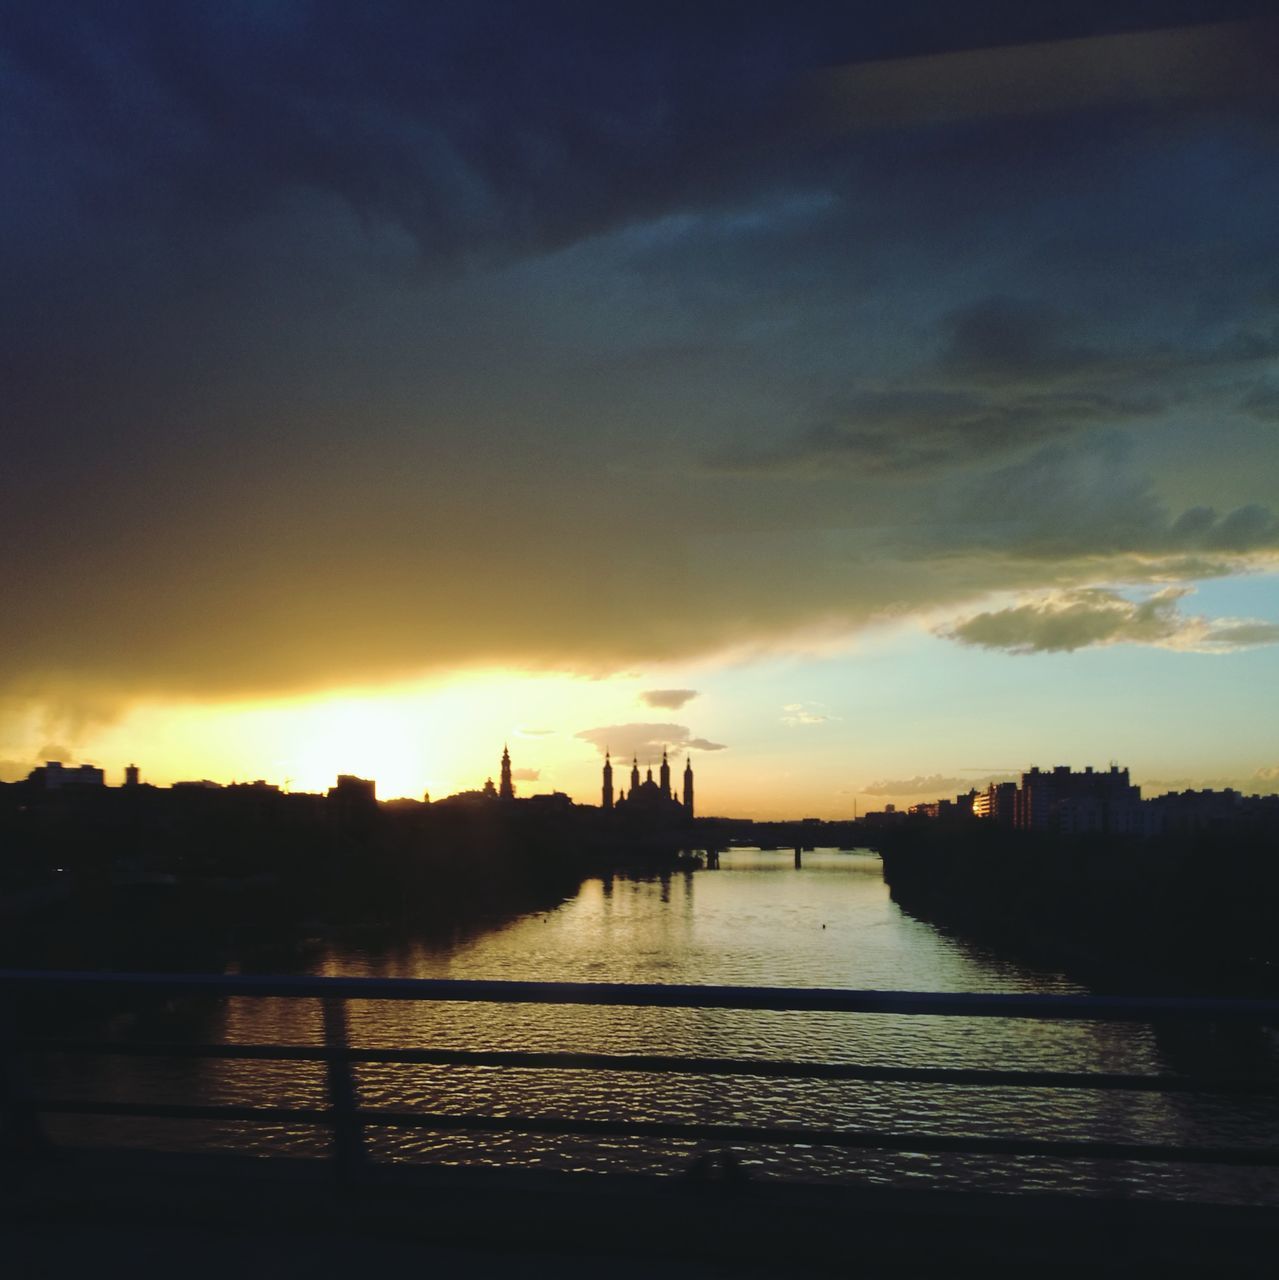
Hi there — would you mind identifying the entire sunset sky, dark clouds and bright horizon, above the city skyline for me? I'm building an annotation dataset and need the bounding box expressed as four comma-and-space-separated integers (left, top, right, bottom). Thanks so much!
0, 0, 1279, 817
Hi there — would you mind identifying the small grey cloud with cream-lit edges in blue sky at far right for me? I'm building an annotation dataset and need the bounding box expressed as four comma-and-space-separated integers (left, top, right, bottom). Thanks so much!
941, 588, 1279, 654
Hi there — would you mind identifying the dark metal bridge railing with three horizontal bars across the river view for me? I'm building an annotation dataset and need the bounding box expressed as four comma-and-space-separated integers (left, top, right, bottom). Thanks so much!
0, 970, 1279, 1179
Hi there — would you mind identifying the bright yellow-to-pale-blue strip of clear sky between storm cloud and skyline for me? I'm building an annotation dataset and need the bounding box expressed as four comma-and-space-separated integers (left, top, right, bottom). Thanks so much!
0, 576, 1279, 818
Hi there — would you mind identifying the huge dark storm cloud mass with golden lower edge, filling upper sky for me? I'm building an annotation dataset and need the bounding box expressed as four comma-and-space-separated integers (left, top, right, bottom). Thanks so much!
0, 0, 1279, 716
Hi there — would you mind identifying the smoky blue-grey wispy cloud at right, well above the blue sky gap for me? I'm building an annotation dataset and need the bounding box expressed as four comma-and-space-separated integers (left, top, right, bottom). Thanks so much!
707, 285, 1279, 476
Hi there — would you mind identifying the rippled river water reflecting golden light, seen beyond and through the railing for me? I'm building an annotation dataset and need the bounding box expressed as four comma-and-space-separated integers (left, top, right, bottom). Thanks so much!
32, 850, 1279, 1202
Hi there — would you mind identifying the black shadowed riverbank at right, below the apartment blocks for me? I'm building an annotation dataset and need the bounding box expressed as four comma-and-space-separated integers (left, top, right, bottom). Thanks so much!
878, 823, 1279, 996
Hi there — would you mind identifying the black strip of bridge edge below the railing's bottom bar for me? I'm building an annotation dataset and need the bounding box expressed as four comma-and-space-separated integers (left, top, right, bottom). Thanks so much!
0, 1152, 1279, 1277
